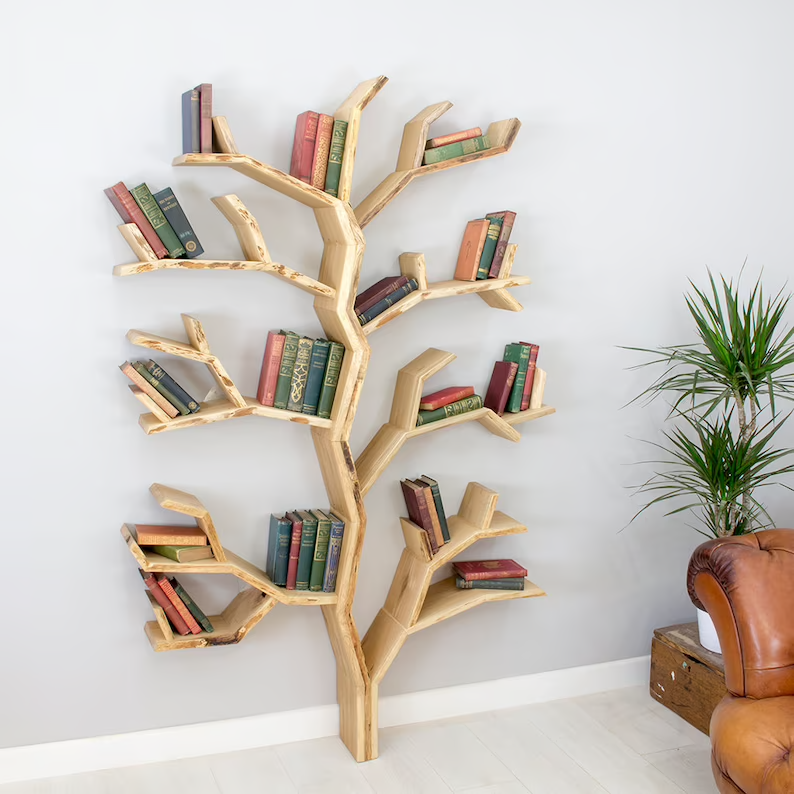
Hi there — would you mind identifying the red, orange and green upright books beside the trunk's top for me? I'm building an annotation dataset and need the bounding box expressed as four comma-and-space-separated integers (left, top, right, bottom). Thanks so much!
289, 110, 347, 196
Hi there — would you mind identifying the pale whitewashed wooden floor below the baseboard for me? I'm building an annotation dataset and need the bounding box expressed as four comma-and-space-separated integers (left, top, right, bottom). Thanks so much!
0, 687, 717, 794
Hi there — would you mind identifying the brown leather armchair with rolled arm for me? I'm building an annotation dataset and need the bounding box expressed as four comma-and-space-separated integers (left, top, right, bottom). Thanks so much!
687, 529, 794, 794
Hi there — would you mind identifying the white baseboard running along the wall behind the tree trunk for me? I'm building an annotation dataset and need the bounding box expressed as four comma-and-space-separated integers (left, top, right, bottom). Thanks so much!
0, 656, 650, 784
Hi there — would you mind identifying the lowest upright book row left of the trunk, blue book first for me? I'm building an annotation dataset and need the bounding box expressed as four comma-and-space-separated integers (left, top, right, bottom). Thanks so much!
265, 510, 345, 593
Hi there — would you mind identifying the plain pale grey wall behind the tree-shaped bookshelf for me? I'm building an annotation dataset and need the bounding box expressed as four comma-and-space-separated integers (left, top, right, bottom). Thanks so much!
0, 0, 794, 746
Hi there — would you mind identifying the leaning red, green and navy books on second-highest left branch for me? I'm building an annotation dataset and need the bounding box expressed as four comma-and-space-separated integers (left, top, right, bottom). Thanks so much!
105, 182, 204, 259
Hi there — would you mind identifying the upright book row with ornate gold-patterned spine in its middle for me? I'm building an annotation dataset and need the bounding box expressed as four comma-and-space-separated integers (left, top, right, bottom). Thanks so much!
256, 330, 345, 419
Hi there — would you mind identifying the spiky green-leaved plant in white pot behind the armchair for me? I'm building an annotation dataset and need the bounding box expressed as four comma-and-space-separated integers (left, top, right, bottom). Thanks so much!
627, 273, 794, 652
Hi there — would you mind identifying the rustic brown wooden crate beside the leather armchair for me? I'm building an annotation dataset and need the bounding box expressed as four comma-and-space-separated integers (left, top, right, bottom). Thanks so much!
651, 623, 727, 734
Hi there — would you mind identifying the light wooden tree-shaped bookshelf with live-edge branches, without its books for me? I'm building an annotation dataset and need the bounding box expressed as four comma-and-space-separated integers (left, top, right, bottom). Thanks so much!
114, 77, 554, 761
